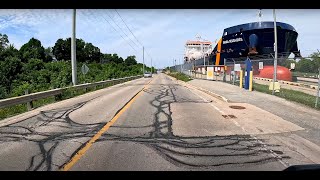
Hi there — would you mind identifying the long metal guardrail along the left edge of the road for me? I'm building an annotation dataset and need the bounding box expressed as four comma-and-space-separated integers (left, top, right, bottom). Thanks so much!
0, 75, 142, 110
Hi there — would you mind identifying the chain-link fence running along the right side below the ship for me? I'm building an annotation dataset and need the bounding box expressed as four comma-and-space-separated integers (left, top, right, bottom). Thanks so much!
170, 55, 320, 106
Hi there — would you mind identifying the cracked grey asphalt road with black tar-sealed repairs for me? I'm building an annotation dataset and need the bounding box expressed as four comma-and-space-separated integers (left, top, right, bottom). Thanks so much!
0, 74, 319, 171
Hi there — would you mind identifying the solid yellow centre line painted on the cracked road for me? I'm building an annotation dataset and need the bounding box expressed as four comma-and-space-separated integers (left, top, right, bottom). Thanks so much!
60, 79, 153, 171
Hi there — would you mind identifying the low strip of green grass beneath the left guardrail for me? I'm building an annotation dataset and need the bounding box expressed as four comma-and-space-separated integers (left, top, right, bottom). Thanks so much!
0, 79, 125, 120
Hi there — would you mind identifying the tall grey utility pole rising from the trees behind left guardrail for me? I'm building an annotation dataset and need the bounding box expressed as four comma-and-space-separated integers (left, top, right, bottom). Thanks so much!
71, 9, 77, 86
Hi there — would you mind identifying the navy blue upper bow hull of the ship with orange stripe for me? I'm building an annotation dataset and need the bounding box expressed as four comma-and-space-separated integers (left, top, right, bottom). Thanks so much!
208, 22, 301, 65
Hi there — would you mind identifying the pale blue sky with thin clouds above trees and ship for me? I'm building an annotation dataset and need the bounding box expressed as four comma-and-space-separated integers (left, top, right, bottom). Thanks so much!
0, 9, 320, 68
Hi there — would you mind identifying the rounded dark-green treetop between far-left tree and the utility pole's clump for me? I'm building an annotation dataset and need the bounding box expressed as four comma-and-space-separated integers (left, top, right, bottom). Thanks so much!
19, 38, 45, 62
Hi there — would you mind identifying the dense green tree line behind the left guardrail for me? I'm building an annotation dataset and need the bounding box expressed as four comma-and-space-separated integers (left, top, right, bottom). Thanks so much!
0, 34, 154, 99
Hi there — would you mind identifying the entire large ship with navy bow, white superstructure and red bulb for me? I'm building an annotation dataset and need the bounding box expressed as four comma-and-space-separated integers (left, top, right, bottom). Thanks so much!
184, 10, 301, 81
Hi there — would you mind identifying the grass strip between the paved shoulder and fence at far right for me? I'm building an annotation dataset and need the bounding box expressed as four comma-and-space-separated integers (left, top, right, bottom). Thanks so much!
253, 83, 320, 110
